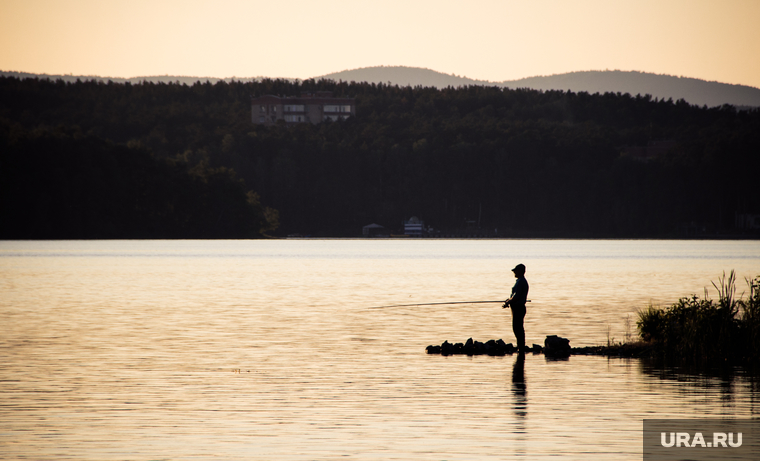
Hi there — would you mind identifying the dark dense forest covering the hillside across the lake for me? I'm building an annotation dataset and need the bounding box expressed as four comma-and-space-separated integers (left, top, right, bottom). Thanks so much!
0, 78, 760, 238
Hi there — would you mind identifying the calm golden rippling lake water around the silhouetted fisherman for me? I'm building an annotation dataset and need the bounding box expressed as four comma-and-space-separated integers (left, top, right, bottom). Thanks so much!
0, 239, 760, 460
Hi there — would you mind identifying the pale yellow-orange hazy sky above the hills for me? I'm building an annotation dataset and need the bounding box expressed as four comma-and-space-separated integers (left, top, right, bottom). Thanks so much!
0, 0, 760, 87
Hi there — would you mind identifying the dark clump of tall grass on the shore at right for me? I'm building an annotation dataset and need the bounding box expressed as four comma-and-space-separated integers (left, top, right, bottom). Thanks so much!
636, 271, 760, 365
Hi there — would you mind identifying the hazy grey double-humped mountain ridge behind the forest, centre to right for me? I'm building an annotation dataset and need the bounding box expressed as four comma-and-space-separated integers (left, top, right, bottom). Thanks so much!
318, 66, 760, 107
